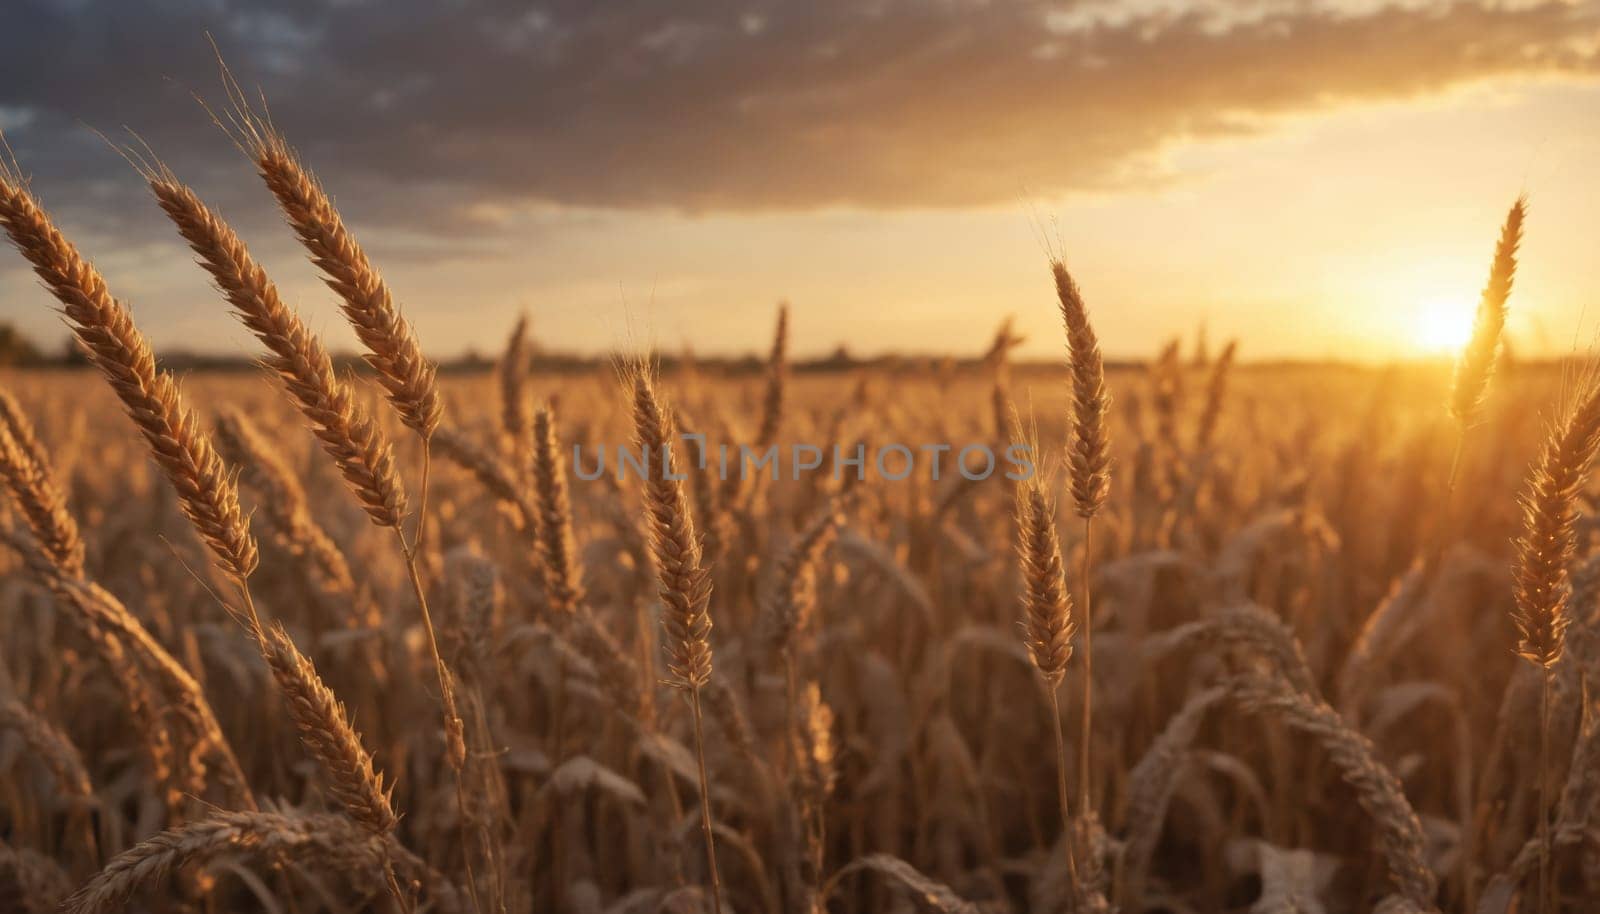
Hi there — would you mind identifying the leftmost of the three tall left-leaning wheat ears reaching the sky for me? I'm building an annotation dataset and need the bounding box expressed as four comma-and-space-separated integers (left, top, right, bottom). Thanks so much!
0, 165, 256, 581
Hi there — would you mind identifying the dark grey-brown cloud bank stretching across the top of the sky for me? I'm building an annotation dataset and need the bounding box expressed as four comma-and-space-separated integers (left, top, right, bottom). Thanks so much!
0, 0, 1600, 234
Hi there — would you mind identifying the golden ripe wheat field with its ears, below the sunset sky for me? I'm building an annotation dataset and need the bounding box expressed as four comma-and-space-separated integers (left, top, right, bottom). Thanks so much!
0, 108, 1600, 914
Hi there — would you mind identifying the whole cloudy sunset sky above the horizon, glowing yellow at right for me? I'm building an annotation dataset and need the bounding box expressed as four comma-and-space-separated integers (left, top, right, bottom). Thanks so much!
0, 0, 1600, 360
